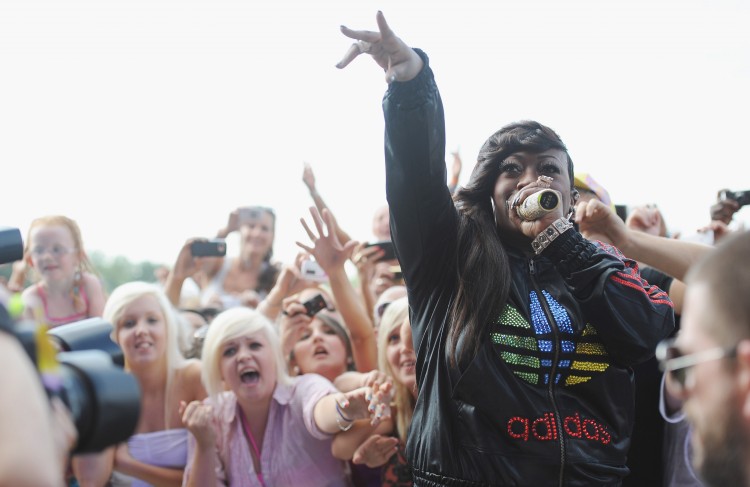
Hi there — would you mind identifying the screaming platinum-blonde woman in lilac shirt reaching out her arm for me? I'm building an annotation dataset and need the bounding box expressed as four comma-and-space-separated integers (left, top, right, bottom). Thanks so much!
178, 307, 379, 487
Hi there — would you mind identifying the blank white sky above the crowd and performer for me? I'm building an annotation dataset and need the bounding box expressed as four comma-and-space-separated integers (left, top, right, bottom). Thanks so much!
0, 0, 750, 264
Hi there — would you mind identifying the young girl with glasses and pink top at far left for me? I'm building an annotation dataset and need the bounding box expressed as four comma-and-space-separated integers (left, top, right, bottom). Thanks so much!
22, 215, 105, 328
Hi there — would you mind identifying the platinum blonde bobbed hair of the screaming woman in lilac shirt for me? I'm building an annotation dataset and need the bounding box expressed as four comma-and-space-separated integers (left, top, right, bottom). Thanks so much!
201, 306, 292, 397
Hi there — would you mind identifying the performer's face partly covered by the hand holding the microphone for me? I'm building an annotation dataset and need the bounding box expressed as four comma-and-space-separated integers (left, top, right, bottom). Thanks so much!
493, 149, 573, 239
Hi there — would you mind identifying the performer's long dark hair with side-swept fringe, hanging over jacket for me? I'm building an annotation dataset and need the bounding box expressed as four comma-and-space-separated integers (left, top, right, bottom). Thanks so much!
448, 120, 574, 367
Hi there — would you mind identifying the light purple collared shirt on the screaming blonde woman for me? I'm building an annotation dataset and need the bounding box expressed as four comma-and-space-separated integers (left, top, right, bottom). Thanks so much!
183, 374, 349, 487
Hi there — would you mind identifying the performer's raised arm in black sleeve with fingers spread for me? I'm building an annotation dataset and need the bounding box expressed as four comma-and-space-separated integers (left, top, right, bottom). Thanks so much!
338, 12, 458, 312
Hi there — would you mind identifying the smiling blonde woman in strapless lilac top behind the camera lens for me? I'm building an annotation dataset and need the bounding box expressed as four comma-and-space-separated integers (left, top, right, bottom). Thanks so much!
74, 282, 206, 487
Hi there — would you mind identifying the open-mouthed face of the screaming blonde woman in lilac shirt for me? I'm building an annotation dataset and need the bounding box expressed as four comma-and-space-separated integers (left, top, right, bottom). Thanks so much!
219, 330, 277, 403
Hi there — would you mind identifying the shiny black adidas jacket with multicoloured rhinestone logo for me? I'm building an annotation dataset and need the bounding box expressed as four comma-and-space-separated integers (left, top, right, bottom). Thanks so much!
383, 50, 674, 486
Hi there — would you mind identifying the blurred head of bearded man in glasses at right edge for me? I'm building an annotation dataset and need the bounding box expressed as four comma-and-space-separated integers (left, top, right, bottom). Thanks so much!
657, 231, 750, 486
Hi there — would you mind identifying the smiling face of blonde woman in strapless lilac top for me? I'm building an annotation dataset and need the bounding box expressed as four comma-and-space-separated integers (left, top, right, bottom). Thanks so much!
117, 295, 167, 369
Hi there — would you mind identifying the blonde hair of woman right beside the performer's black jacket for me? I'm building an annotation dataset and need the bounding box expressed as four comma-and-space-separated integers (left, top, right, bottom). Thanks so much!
378, 297, 415, 441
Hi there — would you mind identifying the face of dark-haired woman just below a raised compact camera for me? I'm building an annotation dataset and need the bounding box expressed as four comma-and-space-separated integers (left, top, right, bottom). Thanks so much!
293, 318, 347, 381
